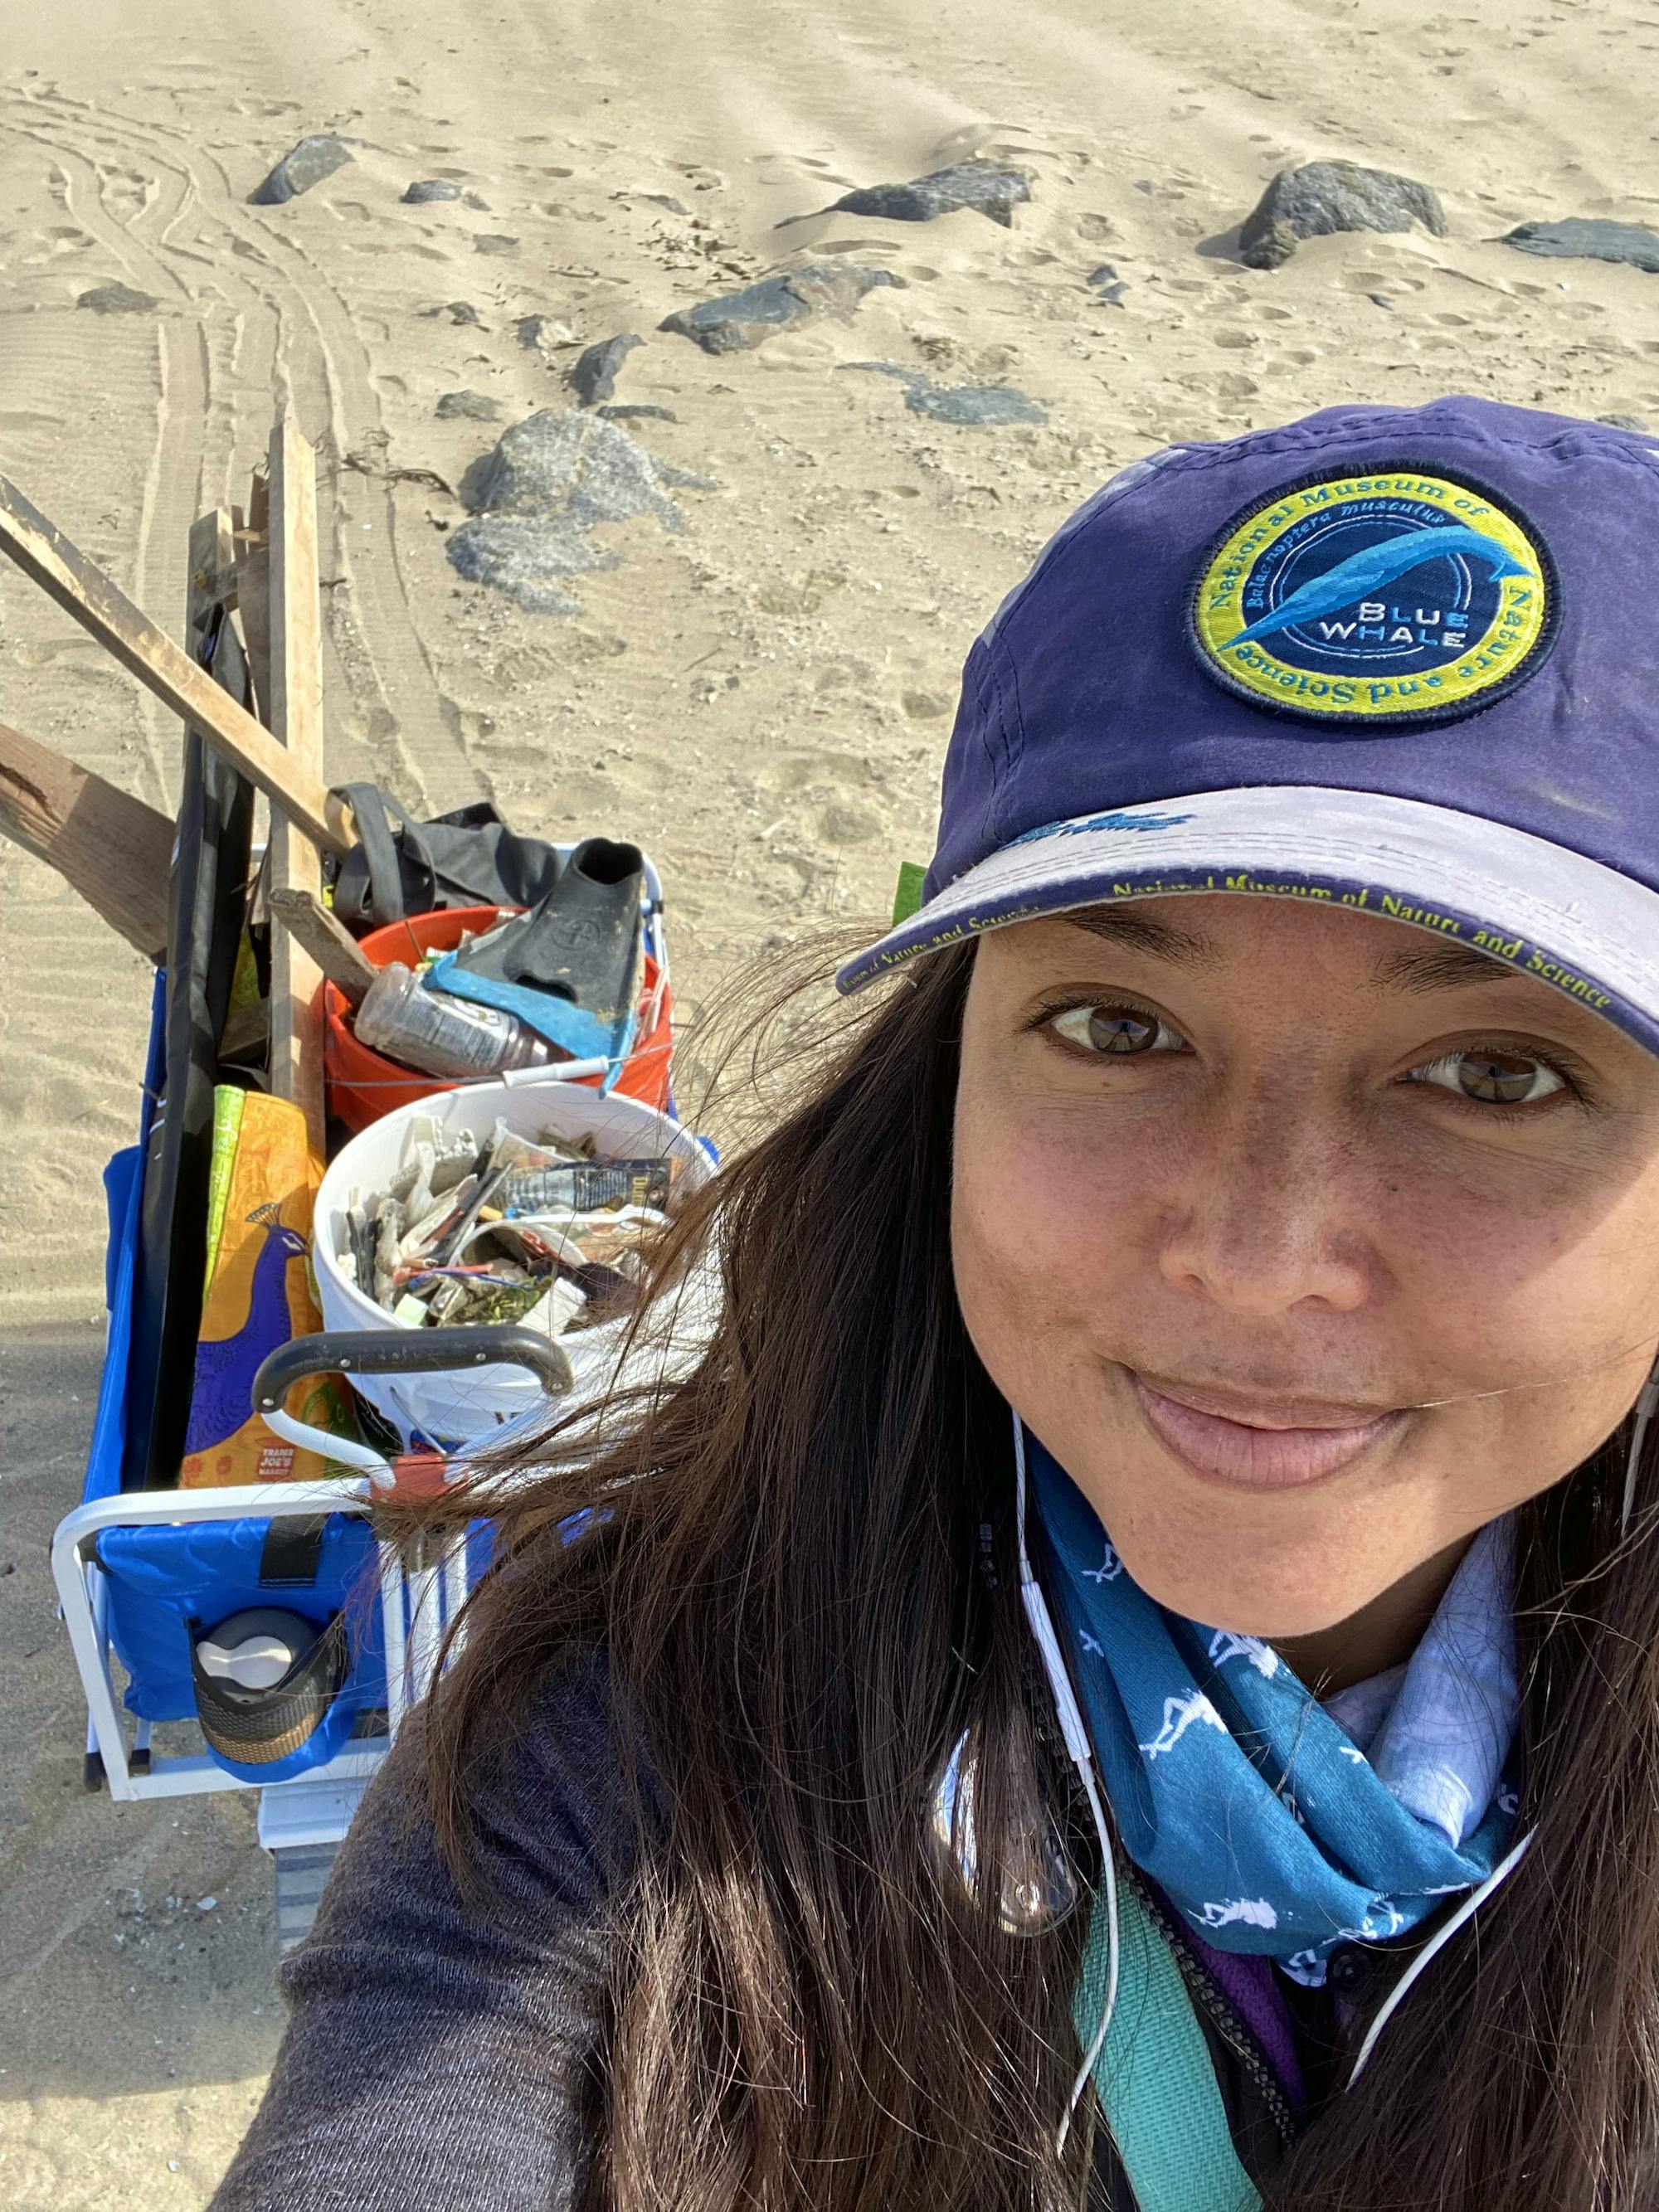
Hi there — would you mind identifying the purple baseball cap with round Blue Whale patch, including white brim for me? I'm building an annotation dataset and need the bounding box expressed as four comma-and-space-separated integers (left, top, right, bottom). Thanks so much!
836, 398, 1659, 1051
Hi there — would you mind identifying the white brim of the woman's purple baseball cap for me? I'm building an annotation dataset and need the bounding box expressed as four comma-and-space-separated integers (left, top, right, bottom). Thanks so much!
836, 785, 1659, 1053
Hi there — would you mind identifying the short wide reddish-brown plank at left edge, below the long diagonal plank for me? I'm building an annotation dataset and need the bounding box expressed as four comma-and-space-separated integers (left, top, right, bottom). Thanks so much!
0, 723, 173, 965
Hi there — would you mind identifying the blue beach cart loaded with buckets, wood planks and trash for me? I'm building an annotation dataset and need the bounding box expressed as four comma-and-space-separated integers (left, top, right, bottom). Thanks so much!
0, 416, 703, 1860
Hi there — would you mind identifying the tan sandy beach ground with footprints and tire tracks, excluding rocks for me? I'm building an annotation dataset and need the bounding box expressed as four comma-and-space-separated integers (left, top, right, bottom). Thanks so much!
0, 0, 1659, 2212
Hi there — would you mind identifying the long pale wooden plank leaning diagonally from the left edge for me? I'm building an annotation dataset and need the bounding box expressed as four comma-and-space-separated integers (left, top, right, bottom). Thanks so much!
0, 475, 352, 852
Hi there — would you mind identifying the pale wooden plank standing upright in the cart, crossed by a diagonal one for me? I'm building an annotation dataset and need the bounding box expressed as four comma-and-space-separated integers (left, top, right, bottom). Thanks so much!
265, 416, 328, 1159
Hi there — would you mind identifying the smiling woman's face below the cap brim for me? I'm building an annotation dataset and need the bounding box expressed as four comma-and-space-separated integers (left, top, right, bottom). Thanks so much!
951, 896, 1659, 1639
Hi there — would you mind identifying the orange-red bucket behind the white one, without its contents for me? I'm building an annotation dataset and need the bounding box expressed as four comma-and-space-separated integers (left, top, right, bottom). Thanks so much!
323, 907, 673, 1135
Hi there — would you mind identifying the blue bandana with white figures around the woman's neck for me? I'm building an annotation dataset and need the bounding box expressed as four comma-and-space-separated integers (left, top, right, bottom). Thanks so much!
1029, 1442, 1520, 1984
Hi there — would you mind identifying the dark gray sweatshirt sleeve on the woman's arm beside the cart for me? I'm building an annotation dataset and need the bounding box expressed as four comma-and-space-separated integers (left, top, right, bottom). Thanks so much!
208, 1661, 630, 2212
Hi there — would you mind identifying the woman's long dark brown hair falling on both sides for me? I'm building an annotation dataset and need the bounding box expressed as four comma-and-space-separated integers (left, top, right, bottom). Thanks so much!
409, 946, 1659, 2212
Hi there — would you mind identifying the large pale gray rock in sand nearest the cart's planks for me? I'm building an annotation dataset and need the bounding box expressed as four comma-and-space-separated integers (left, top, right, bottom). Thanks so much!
445, 407, 694, 615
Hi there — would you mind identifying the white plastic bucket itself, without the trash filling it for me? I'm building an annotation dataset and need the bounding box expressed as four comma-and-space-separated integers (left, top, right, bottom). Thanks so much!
312, 1075, 714, 1451
